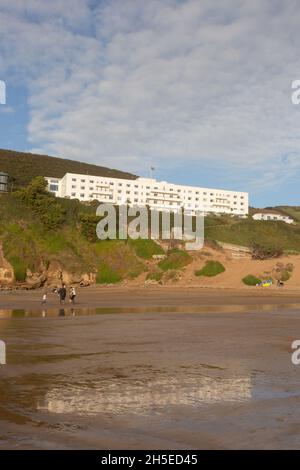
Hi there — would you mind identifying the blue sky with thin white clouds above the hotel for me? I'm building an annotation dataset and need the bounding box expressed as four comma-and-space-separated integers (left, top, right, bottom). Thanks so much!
0, 0, 300, 207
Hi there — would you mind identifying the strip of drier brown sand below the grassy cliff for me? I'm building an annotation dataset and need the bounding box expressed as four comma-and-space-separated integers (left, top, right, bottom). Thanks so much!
0, 285, 300, 309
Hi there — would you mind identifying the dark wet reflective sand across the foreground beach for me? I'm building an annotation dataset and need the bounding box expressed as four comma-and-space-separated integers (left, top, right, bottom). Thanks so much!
0, 300, 300, 449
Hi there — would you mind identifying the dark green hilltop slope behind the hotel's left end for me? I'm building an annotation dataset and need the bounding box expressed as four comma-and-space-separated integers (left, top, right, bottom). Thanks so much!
0, 149, 136, 186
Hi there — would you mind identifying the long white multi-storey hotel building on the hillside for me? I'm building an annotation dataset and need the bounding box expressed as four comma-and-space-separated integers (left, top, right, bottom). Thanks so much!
45, 173, 248, 217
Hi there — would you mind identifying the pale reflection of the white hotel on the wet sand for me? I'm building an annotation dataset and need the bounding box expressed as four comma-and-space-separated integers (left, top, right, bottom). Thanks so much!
38, 375, 252, 415
